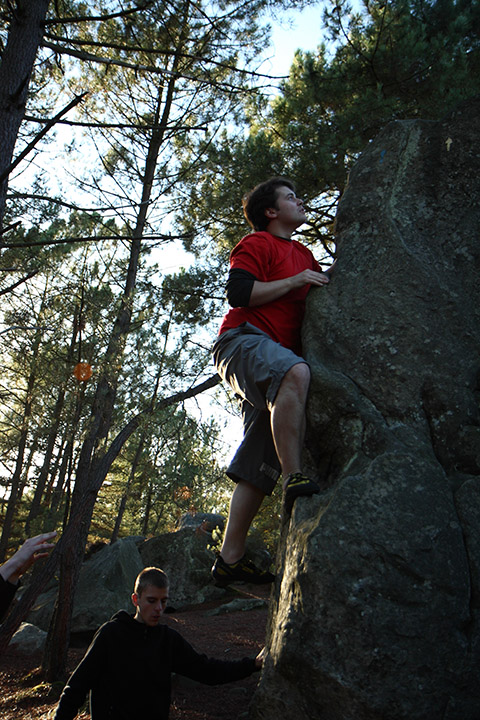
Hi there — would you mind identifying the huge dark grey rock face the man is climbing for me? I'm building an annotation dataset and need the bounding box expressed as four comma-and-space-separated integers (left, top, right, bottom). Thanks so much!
250, 100, 480, 720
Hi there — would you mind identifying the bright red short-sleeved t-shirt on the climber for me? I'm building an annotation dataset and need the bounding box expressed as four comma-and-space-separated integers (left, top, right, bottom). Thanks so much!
219, 232, 322, 353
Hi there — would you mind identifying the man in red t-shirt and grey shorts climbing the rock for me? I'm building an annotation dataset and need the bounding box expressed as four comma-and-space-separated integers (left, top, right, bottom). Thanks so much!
212, 177, 333, 586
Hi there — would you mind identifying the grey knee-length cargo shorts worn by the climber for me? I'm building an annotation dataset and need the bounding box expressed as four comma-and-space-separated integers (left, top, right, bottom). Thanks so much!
212, 323, 305, 495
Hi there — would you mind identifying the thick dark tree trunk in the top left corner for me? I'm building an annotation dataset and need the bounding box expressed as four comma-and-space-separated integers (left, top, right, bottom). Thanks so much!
0, 0, 49, 225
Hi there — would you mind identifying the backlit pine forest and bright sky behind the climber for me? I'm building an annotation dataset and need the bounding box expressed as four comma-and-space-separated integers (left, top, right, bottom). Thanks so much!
0, 0, 480, 678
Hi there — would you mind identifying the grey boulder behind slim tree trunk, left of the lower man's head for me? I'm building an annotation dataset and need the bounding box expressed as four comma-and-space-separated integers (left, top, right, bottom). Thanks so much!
28, 538, 144, 633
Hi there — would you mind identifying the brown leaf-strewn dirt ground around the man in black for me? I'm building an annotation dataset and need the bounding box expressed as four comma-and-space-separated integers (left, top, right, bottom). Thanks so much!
0, 586, 269, 720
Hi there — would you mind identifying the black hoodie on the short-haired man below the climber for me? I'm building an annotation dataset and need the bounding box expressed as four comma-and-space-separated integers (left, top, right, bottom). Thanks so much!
55, 610, 256, 720
